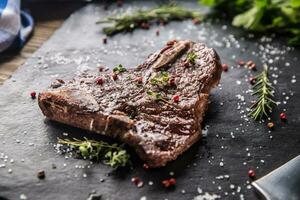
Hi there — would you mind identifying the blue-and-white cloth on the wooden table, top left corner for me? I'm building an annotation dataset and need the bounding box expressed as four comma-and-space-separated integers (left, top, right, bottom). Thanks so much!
0, 0, 34, 52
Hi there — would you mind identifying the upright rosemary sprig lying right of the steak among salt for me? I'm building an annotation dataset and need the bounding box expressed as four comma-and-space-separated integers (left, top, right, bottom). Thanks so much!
249, 64, 276, 120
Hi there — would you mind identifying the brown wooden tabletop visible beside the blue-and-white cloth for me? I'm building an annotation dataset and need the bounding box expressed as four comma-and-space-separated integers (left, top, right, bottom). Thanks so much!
0, 1, 85, 85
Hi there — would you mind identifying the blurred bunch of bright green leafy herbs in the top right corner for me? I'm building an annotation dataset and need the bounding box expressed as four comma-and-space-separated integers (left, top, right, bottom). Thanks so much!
198, 0, 300, 45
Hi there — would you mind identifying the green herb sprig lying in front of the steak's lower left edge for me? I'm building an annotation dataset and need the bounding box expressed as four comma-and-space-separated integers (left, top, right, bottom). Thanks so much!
58, 138, 130, 169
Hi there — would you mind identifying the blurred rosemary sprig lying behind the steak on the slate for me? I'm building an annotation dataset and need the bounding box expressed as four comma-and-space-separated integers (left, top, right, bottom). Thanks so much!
96, 5, 203, 35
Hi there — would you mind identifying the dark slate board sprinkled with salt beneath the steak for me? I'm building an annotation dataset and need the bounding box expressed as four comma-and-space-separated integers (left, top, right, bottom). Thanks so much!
0, 1, 300, 200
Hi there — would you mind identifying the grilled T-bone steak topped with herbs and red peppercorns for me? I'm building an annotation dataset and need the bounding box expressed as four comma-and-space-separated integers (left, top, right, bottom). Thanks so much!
39, 40, 222, 167
